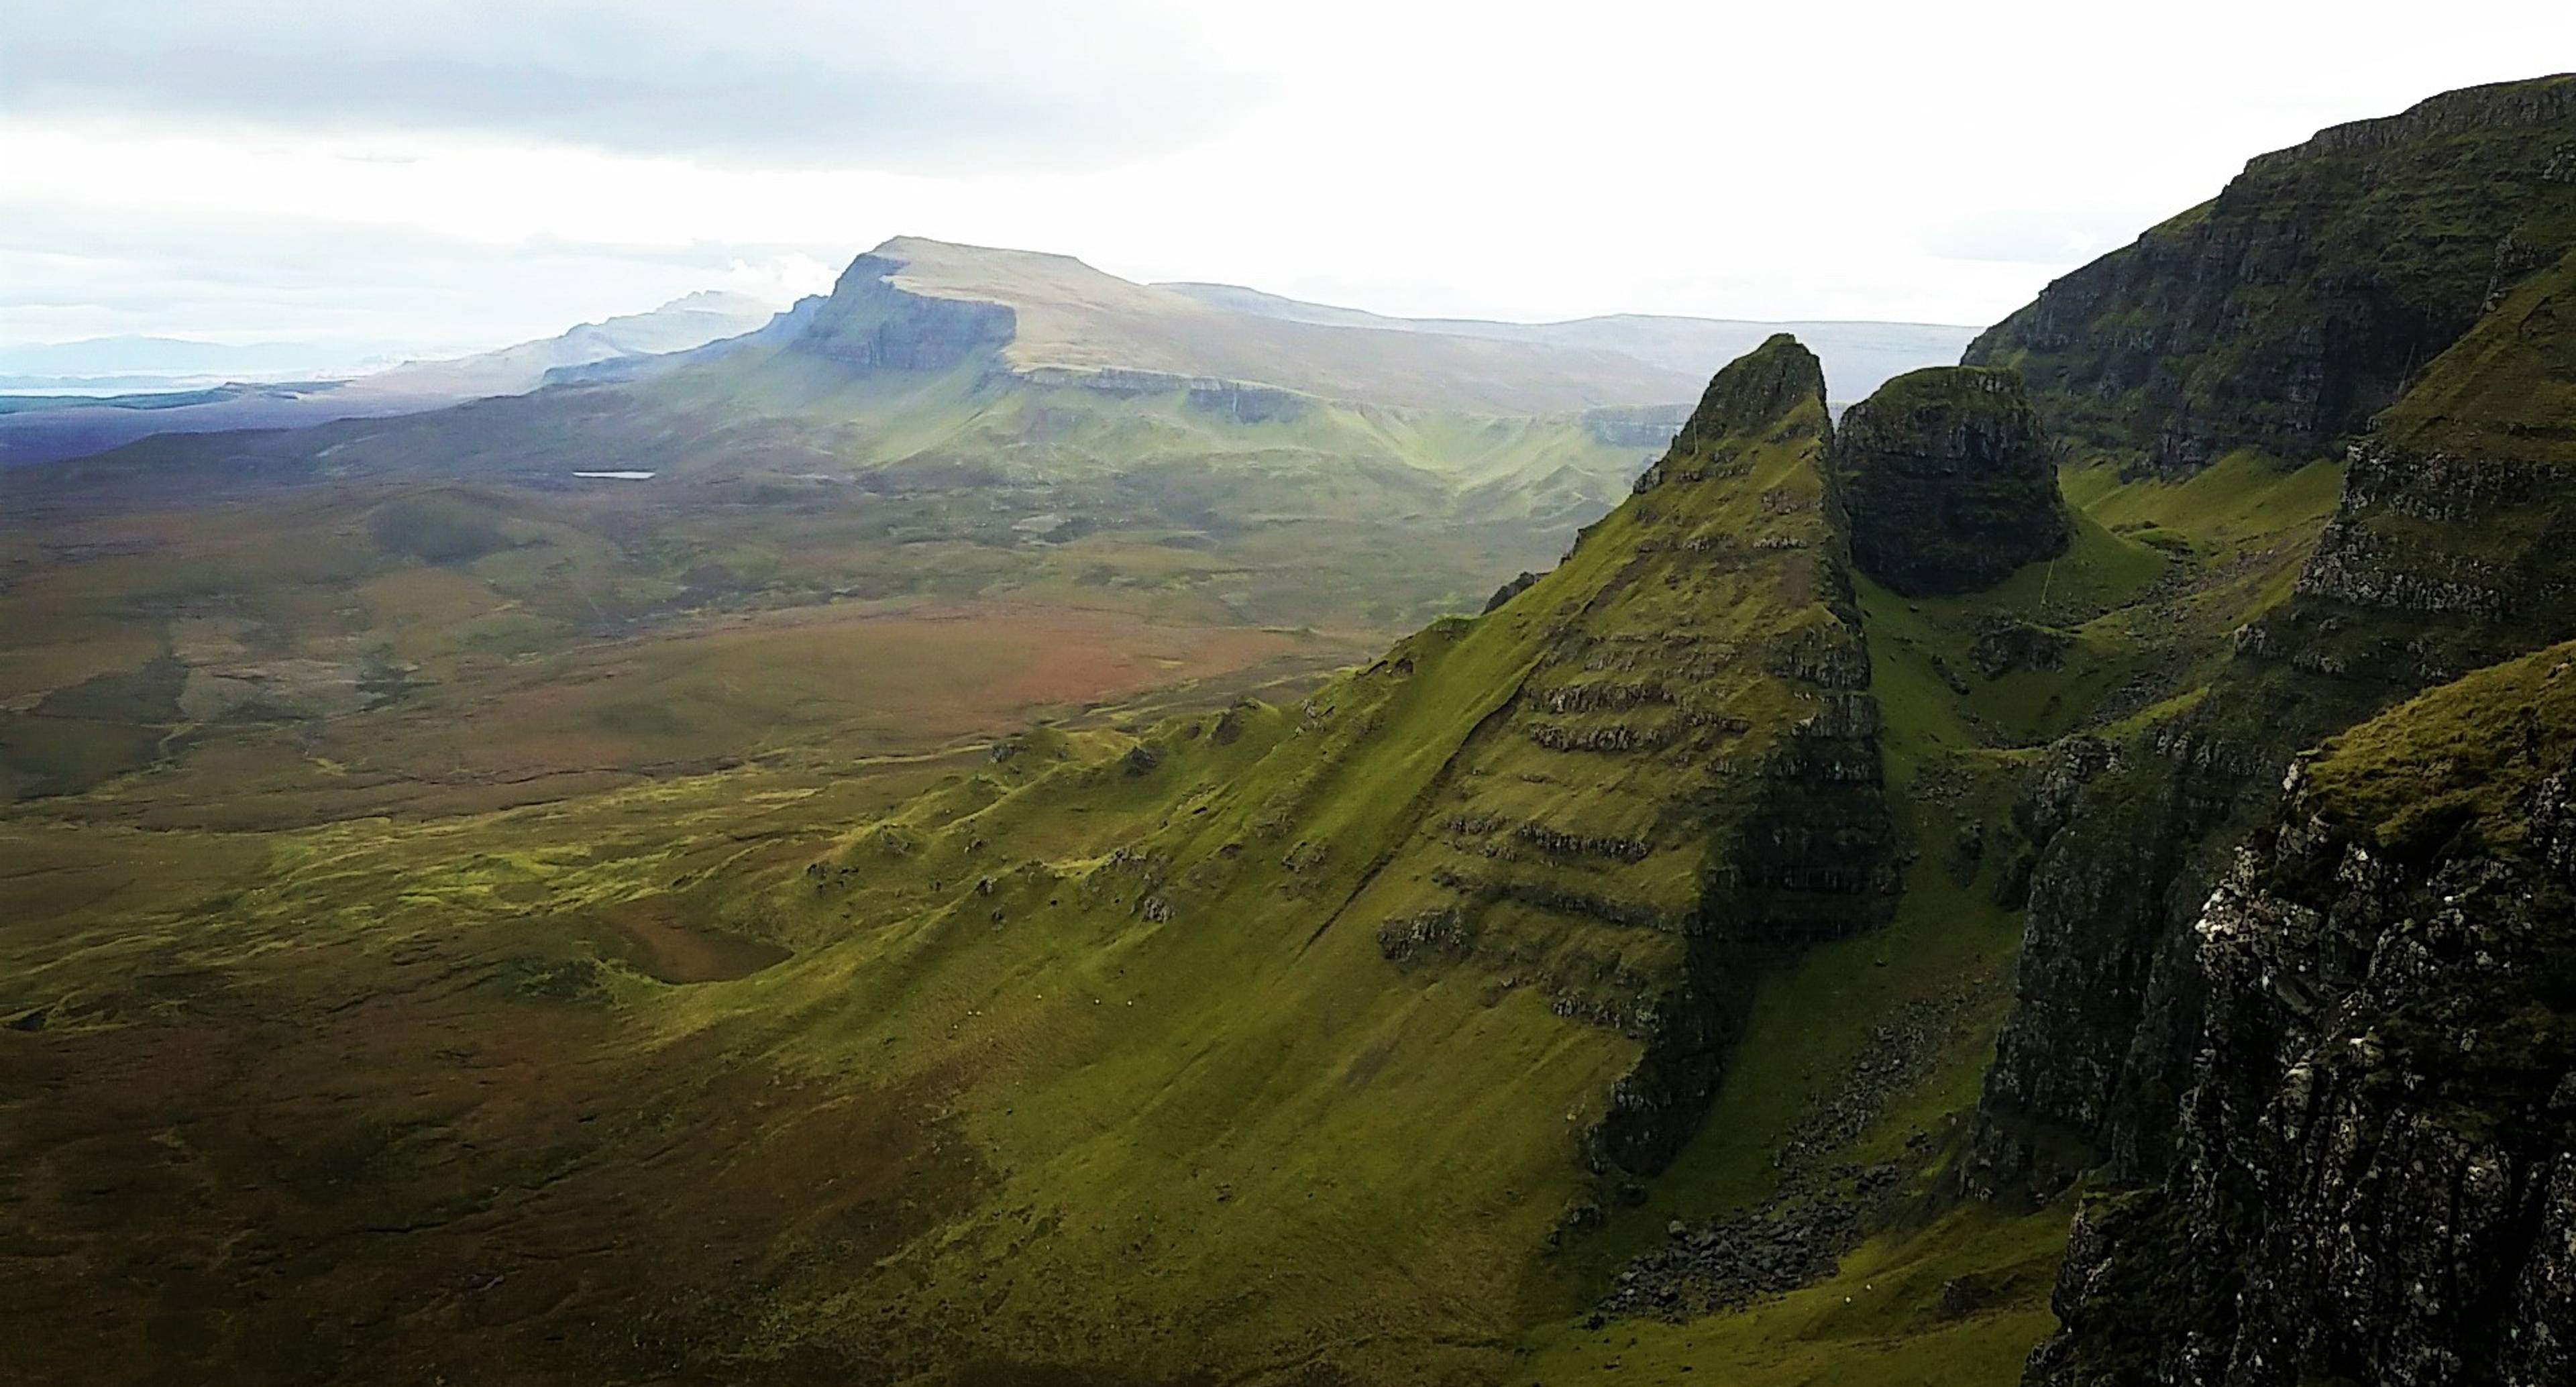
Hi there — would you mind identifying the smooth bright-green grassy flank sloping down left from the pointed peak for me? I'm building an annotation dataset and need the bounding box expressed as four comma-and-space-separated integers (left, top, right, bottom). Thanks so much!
602, 342, 1885, 1377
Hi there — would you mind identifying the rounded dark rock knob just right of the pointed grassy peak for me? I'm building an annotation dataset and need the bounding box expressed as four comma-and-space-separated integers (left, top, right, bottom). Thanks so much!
1834, 366, 2071, 597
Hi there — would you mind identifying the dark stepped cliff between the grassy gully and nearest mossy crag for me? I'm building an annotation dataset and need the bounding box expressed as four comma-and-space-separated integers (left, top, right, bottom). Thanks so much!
1960, 443, 2576, 1199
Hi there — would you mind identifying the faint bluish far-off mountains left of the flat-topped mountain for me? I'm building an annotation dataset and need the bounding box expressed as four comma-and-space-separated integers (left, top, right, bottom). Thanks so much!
0, 291, 773, 465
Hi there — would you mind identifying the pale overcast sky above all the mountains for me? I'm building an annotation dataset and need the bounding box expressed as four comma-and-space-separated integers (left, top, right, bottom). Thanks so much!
0, 0, 2576, 350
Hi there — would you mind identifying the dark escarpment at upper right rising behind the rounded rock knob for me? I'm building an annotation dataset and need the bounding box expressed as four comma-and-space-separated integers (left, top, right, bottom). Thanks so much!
1966, 77, 2576, 474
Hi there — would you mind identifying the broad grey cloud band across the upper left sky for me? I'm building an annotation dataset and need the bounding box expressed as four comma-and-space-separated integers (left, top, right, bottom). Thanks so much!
0, 0, 1252, 172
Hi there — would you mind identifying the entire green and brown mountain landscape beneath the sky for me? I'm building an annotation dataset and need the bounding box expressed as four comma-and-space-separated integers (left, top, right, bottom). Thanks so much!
0, 80, 2576, 1387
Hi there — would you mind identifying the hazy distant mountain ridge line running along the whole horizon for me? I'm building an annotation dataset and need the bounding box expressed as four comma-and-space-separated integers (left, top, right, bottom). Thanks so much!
0, 237, 1973, 463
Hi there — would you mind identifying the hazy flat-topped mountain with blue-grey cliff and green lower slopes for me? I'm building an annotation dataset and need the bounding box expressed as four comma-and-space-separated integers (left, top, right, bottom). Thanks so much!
0, 239, 1731, 656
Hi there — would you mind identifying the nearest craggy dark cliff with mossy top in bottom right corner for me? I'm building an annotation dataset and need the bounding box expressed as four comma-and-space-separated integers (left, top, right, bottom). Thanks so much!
2030, 646, 2576, 1387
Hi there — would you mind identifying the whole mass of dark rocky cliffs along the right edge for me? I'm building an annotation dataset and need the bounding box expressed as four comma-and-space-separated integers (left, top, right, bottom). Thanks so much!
1957, 80, 2576, 1387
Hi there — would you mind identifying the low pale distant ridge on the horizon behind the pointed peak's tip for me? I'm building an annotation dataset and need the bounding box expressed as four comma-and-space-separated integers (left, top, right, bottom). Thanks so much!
1179, 283, 1976, 402
